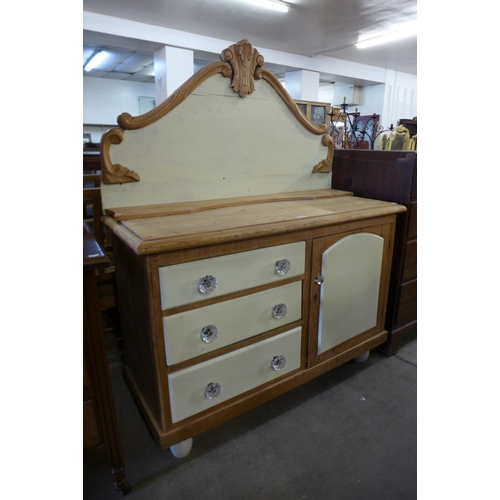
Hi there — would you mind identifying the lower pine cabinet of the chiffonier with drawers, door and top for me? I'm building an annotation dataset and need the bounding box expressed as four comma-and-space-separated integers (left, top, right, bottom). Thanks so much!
106, 190, 404, 454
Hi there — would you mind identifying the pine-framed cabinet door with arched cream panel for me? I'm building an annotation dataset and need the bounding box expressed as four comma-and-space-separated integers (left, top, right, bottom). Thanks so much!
310, 224, 391, 362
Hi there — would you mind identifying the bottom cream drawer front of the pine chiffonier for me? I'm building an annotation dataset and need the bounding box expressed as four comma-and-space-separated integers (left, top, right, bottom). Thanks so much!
168, 327, 302, 423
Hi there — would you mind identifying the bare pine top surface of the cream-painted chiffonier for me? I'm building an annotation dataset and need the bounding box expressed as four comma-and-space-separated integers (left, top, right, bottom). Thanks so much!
105, 190, 406, 255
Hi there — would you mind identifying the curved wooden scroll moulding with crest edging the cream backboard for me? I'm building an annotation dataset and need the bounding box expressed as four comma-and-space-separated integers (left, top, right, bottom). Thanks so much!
101, 40, 333, 184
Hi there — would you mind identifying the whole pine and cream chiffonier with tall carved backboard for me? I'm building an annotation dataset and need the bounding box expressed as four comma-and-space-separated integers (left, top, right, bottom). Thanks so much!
101, 40, 406, 456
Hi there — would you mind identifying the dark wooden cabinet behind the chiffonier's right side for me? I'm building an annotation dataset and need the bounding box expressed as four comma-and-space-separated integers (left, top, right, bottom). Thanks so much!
332, 150, 417, 354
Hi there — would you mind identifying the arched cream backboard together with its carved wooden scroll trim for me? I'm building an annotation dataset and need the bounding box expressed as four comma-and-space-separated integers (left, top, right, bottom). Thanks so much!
101, 39, 333, 189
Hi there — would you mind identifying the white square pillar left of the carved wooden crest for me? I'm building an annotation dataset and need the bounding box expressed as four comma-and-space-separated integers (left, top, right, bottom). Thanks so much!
154, 47, 194, 105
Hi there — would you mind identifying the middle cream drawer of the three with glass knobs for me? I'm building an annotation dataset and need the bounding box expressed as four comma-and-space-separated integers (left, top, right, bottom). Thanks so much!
163, 281, 302, 366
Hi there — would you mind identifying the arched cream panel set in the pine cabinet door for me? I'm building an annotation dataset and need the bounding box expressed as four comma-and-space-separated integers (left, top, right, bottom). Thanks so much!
318, 233, 384, 354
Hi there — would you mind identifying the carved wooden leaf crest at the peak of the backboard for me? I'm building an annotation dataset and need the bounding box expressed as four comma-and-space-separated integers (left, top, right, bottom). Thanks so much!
221, 40, 264, 97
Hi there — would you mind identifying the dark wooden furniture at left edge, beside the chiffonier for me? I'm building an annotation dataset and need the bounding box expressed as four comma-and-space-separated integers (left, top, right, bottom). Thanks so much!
83, 223, 131, 494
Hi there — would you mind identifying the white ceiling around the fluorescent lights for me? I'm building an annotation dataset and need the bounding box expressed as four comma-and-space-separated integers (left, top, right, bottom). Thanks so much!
83, 0, 417, 82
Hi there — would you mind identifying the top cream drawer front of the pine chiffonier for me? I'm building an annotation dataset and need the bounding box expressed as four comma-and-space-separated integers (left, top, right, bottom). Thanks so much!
159, 241, 305, 310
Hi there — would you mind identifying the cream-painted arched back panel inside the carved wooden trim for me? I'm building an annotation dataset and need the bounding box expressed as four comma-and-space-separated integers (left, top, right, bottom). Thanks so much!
101, 74, 331, 208
